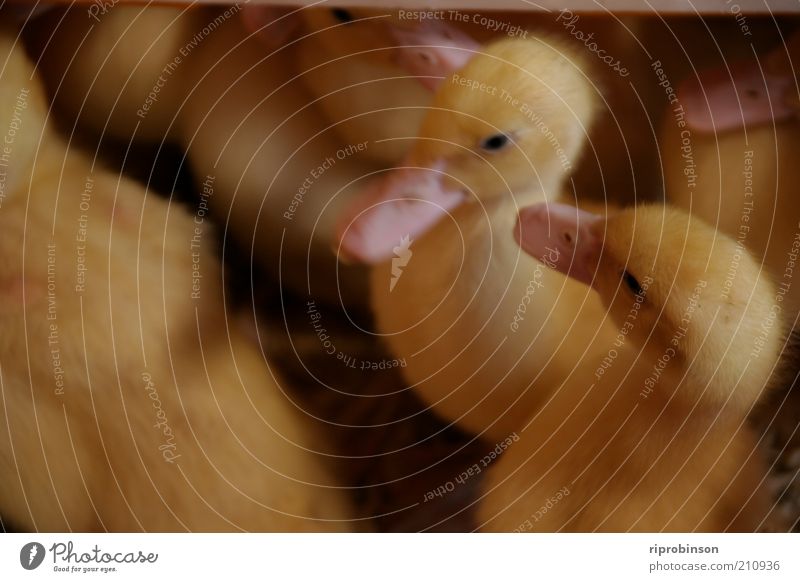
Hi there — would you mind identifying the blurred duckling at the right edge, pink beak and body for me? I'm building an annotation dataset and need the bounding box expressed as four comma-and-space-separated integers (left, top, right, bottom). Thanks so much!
646, 19, 800, 326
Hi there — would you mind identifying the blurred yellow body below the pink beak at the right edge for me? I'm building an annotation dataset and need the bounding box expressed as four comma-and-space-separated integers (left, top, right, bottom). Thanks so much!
662, 101, 800, 334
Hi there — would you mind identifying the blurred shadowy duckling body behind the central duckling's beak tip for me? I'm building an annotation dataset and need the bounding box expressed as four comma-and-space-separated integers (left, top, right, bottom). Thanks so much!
178, 10, 373, 302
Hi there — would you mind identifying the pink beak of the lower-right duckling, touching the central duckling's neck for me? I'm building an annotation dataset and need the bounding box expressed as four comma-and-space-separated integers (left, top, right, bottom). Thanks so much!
514, 202, 603, 285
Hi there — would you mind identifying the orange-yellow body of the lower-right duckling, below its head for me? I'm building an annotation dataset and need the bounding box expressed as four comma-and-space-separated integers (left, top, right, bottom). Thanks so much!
478, 348, 771, 532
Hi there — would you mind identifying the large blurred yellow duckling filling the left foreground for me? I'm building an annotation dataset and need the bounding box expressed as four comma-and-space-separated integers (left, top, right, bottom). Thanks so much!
0, 34, 353, 531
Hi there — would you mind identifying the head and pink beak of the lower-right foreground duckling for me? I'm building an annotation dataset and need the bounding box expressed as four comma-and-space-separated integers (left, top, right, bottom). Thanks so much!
515, 203, 786, 409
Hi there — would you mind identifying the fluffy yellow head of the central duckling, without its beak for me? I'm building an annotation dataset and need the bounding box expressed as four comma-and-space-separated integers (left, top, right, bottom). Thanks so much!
409, 38, 595, 200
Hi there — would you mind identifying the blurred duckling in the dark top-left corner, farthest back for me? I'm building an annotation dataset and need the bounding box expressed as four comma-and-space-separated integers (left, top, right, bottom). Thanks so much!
25, 4, 194, 143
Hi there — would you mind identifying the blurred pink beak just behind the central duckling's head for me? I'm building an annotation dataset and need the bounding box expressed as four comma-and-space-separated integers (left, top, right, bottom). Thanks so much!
389, 21, 480, 91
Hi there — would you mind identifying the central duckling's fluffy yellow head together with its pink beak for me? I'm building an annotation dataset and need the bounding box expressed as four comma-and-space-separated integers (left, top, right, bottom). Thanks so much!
339, 38, 595, 263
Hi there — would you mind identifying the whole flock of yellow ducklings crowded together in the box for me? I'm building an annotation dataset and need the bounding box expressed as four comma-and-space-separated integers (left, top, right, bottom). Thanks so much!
0, 5, 800, 532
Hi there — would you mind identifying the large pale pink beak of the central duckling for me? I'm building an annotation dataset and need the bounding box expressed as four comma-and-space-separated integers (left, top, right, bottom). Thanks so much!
335, 162, 466, 264
